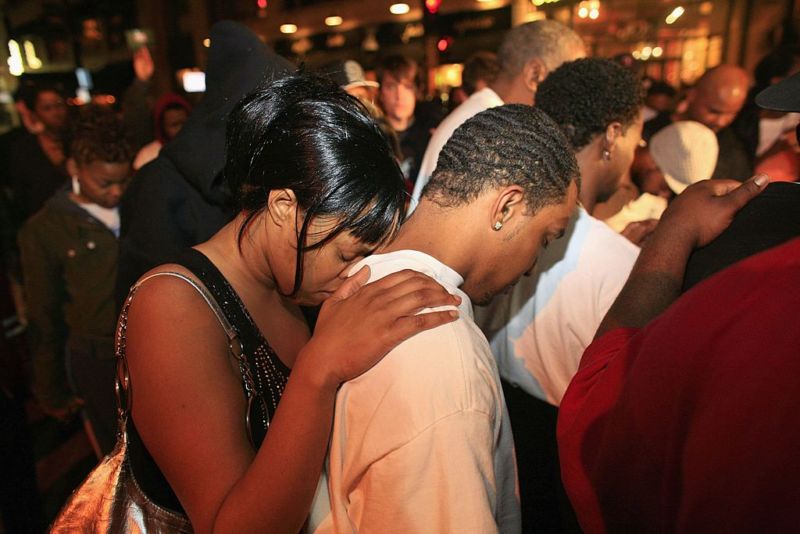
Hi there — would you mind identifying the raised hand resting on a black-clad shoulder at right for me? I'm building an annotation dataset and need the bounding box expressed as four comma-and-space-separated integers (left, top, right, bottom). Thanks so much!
658, 174, 769, 248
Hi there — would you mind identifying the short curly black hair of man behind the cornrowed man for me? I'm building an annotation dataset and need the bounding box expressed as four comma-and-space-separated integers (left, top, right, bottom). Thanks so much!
536, 58, 644, 151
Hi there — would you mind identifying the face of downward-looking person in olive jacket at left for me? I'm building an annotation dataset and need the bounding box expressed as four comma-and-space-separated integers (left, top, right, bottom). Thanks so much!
69, 160, 131, 208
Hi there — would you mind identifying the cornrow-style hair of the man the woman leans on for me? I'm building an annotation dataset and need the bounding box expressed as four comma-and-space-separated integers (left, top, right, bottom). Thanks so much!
423, 104, 579, 214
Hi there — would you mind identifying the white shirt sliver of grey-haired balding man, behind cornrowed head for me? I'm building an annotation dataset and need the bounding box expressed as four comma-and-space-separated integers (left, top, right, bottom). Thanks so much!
408, 87, 503, 215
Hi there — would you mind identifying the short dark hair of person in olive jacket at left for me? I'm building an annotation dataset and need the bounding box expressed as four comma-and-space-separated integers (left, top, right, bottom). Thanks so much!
69, 105, 134, 165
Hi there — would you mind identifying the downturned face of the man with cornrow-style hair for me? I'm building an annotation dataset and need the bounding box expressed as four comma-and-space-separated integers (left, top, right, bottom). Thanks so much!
462, 181, 578, 306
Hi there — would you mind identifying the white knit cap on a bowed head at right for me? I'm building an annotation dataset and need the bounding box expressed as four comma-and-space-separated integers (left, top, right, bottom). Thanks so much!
649, 121, 719, 194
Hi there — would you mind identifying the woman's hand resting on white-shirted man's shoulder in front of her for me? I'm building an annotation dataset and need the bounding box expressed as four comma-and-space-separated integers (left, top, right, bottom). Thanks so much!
298, 267, 461, 387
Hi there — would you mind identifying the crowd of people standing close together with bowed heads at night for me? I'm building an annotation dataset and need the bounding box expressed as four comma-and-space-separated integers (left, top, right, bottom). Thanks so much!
0, 16, 800, 533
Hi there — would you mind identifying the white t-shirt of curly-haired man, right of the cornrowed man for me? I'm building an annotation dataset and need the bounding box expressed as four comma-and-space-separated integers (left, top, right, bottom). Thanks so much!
475, 208, 639, 406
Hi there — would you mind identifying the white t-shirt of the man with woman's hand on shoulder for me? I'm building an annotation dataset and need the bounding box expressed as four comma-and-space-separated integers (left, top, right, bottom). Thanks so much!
317, 250, 521, 534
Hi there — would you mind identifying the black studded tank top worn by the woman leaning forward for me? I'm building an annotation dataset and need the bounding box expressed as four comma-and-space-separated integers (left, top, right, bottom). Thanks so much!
127, 249, 289, 515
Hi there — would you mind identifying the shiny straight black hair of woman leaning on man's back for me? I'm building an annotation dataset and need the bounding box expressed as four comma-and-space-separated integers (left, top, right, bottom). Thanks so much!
224, 74, 406, 294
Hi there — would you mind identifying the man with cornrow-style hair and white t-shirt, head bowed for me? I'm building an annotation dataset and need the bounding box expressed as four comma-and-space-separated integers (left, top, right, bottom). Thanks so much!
318, 104, 578, 533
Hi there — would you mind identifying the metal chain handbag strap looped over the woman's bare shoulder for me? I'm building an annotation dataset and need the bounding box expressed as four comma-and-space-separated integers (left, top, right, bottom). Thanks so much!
114, 271, 258, 440
